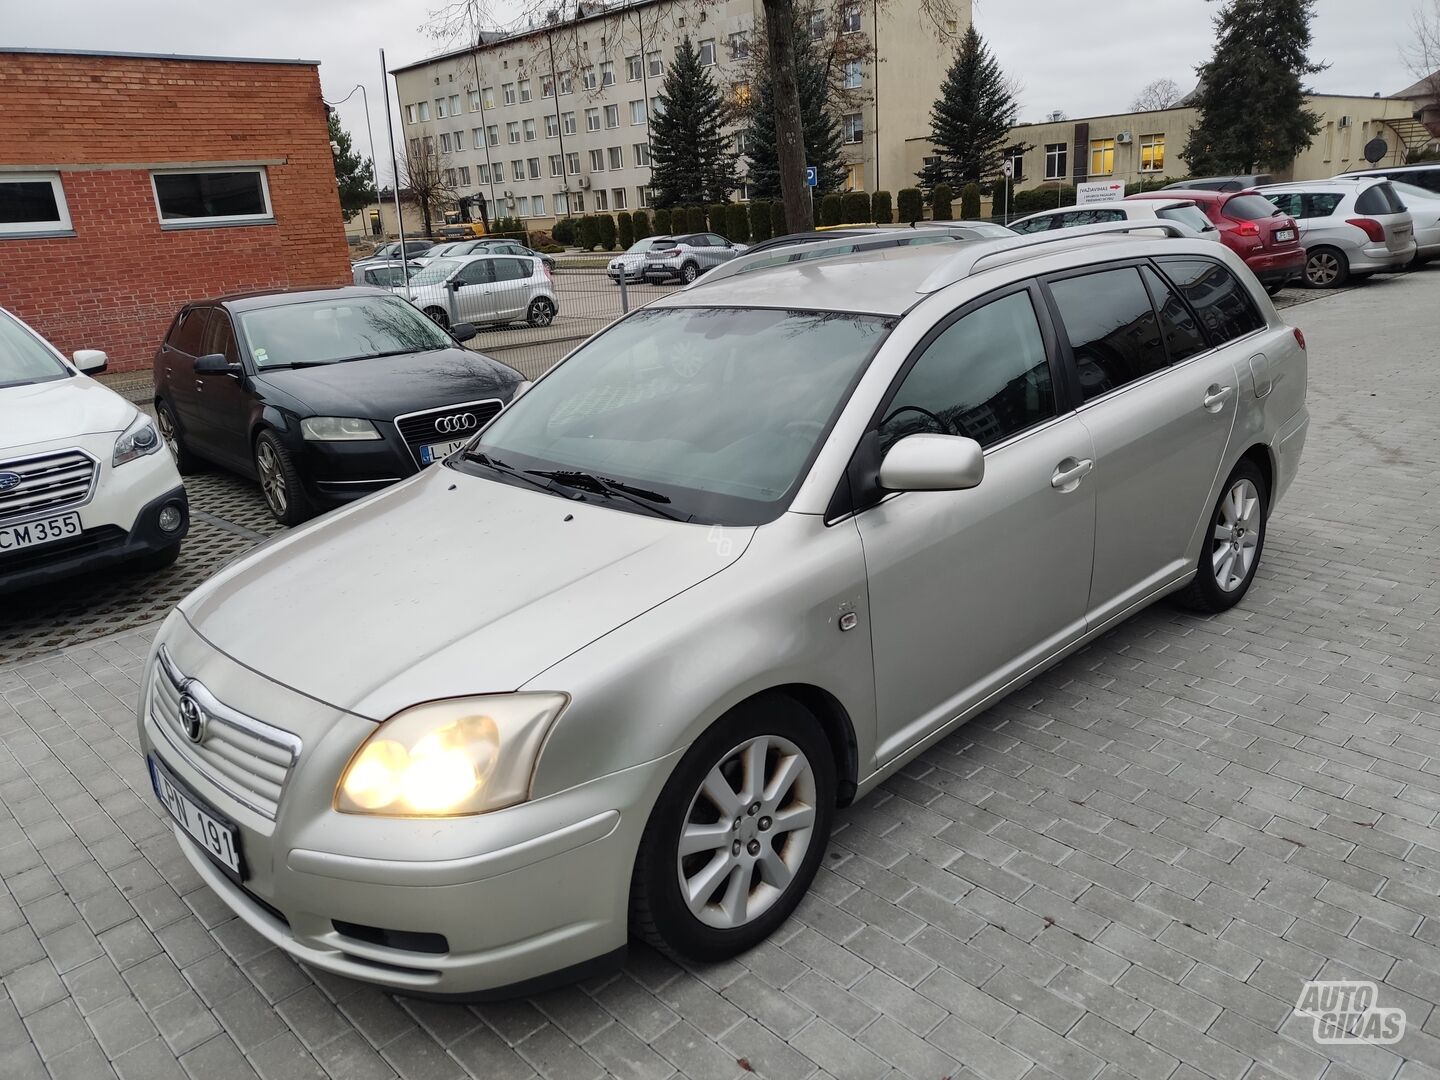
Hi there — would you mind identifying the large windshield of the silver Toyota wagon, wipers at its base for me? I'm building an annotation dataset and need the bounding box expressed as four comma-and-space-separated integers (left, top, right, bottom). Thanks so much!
452, 308, 894, 524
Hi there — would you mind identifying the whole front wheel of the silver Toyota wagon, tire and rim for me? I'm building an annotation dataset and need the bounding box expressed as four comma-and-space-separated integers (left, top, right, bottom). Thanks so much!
631, 694, 835, 960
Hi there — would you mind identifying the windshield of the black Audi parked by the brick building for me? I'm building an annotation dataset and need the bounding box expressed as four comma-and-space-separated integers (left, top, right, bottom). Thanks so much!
239, 293, 455, 372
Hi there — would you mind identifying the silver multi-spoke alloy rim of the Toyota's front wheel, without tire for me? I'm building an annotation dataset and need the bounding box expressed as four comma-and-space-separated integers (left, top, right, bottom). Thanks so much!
675, 734, 816, 930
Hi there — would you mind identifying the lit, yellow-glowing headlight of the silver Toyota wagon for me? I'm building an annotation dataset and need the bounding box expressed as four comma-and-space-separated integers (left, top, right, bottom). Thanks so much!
336, 694, 569, 818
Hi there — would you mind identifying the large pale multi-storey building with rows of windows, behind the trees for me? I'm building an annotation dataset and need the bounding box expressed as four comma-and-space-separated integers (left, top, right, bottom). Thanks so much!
392, 0, 971, 228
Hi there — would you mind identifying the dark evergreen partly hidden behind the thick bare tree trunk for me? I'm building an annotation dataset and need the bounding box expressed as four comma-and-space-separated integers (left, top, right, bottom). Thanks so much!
746, 4, 845, 198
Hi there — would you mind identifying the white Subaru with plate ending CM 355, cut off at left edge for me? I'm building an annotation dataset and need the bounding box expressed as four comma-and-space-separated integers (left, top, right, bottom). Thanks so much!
0, 308, 190, 593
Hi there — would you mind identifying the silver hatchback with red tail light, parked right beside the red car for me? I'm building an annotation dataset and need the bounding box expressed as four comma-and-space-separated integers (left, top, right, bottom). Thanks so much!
1256, 177, 1416, 289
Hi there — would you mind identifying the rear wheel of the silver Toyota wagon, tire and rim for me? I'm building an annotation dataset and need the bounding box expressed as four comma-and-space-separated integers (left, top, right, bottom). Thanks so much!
1178, 461, 1270, 613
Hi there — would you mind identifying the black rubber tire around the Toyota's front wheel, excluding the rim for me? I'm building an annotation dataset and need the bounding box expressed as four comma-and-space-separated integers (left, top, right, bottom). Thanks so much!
634, 694, 835, 960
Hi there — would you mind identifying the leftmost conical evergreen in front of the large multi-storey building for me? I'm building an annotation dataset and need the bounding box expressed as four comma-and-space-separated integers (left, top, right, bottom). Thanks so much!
649, 36, 740, 206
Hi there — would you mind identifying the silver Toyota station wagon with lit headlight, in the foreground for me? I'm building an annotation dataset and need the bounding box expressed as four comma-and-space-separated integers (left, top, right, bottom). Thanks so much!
140, 222, 1308, 995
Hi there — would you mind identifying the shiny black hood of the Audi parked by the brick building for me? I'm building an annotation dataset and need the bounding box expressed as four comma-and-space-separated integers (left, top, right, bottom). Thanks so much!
255, 348, 524, 420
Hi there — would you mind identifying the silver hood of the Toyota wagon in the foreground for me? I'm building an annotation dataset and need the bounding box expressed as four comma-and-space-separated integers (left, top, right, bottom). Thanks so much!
180, 467, 755, 720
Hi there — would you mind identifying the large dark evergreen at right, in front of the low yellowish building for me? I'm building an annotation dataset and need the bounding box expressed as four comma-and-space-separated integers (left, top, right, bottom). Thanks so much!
1185, 0, 1325, 176
